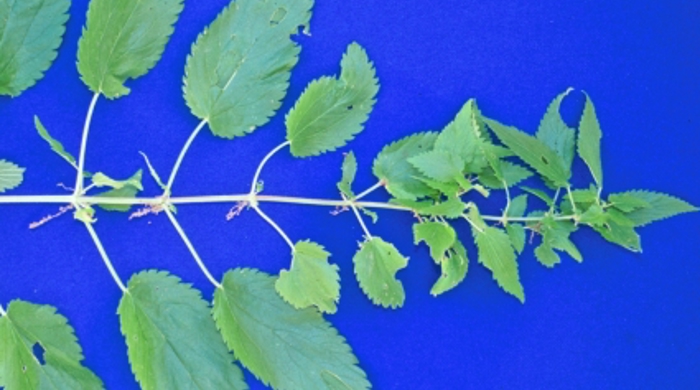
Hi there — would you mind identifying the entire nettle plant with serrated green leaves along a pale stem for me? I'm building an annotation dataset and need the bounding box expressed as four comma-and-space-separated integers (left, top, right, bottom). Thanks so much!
0, 0, 696, 390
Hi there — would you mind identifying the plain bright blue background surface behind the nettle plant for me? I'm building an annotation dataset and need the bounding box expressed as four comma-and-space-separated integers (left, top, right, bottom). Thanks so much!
0, 0, 700, 389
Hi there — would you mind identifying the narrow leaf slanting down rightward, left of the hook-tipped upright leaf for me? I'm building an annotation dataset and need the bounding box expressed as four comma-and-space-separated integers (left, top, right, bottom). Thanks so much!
485, 119, 571, 187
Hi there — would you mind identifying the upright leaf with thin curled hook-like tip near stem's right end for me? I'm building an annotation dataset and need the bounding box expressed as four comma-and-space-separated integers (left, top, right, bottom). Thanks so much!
535, 88, 576, 172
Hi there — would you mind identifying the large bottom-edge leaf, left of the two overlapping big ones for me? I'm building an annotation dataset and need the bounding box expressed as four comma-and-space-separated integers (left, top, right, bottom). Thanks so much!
117, 271, 248, 390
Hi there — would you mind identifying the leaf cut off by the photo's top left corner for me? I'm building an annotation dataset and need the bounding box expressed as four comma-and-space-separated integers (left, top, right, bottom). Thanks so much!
0, 0, 70, 96
